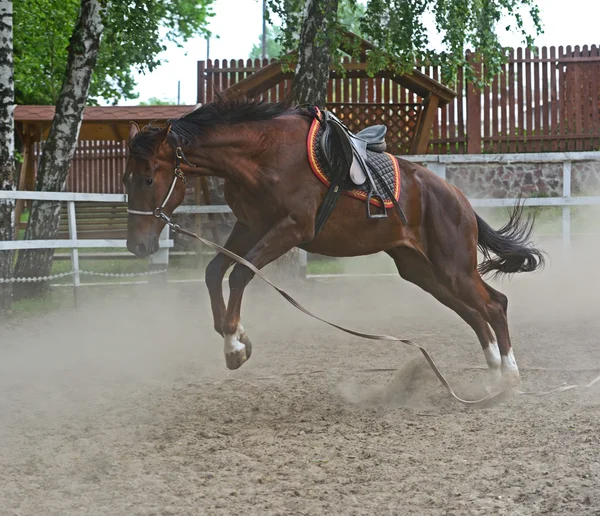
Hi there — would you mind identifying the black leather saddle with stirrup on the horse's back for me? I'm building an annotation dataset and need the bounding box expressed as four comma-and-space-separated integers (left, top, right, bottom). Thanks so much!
315, 109, 406, 233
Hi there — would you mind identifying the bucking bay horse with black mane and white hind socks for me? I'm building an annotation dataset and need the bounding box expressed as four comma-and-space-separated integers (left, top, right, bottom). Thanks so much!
123, 98, 544, 384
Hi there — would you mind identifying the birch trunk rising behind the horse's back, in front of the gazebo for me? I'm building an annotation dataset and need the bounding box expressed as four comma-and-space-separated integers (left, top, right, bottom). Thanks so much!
292, 0, 339, 107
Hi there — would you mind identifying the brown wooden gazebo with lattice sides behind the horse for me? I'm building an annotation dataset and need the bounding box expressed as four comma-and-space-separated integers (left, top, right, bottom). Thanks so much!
197, 32, 456, 154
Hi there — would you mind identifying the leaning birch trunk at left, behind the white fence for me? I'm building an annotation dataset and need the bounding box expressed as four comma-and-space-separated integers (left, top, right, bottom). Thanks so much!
15, 0, 104, 298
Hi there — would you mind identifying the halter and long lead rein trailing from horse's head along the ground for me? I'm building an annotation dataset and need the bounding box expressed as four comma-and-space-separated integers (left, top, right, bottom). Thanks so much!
127, 147, 600, 406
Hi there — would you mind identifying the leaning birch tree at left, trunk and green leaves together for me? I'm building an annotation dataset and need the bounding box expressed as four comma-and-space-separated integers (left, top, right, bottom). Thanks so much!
14, 0, 213, 298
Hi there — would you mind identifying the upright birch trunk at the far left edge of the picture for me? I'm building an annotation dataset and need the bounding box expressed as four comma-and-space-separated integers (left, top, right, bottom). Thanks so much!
0, 0, 15, 313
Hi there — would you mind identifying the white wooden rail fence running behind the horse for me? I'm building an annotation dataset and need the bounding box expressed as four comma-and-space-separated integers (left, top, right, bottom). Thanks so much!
0, 152, 600, 286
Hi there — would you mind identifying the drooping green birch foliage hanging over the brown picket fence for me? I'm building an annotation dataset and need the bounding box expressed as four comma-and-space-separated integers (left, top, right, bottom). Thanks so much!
268, 0, 542, 85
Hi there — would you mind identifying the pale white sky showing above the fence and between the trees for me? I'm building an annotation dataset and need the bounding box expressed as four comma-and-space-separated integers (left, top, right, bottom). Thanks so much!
119, 0, 600, 105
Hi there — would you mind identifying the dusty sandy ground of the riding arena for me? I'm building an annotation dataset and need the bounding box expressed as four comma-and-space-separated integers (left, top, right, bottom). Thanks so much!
0, 239, 600, 516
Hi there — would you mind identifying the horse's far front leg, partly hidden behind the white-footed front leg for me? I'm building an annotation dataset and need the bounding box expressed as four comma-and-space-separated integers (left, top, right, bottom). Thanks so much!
205, 221, 262, 336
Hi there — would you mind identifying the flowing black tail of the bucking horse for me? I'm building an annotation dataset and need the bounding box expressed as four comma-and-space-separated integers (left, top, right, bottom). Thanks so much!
475, 202, 544, 276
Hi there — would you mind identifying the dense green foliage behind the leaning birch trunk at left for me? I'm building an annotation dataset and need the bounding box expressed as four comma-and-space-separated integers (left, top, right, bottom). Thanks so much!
14, 0, 214, 104
